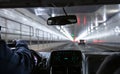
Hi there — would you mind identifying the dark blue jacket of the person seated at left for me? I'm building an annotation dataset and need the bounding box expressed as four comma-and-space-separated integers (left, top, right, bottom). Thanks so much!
0, 40, 32, 74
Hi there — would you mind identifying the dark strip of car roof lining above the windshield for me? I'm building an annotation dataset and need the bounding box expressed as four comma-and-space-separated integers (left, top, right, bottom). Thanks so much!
0, 0, 120, 8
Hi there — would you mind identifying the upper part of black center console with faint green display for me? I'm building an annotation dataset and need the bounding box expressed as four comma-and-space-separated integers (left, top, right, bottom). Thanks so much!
50, 50, 82, 66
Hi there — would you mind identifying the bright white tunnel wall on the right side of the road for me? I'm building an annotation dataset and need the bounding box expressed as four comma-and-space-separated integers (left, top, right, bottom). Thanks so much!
88, 13, 120, 46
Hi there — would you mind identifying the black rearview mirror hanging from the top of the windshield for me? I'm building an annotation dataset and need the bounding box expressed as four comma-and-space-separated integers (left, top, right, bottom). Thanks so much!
47, 15, 77, 25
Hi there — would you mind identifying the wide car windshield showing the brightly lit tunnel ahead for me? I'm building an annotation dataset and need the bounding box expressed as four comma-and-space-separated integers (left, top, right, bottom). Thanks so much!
0, 4, 120, 51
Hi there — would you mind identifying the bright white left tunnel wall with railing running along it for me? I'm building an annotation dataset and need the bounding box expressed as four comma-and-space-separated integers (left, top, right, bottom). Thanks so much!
0, 9, 65, 42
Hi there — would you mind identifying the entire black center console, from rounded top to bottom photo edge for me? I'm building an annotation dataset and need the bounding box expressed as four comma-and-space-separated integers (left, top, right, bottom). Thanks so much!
50, 50, 82, 74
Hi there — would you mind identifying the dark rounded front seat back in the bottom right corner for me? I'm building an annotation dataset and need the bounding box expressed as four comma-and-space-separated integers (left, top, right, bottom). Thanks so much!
96, 54, 120, 74
